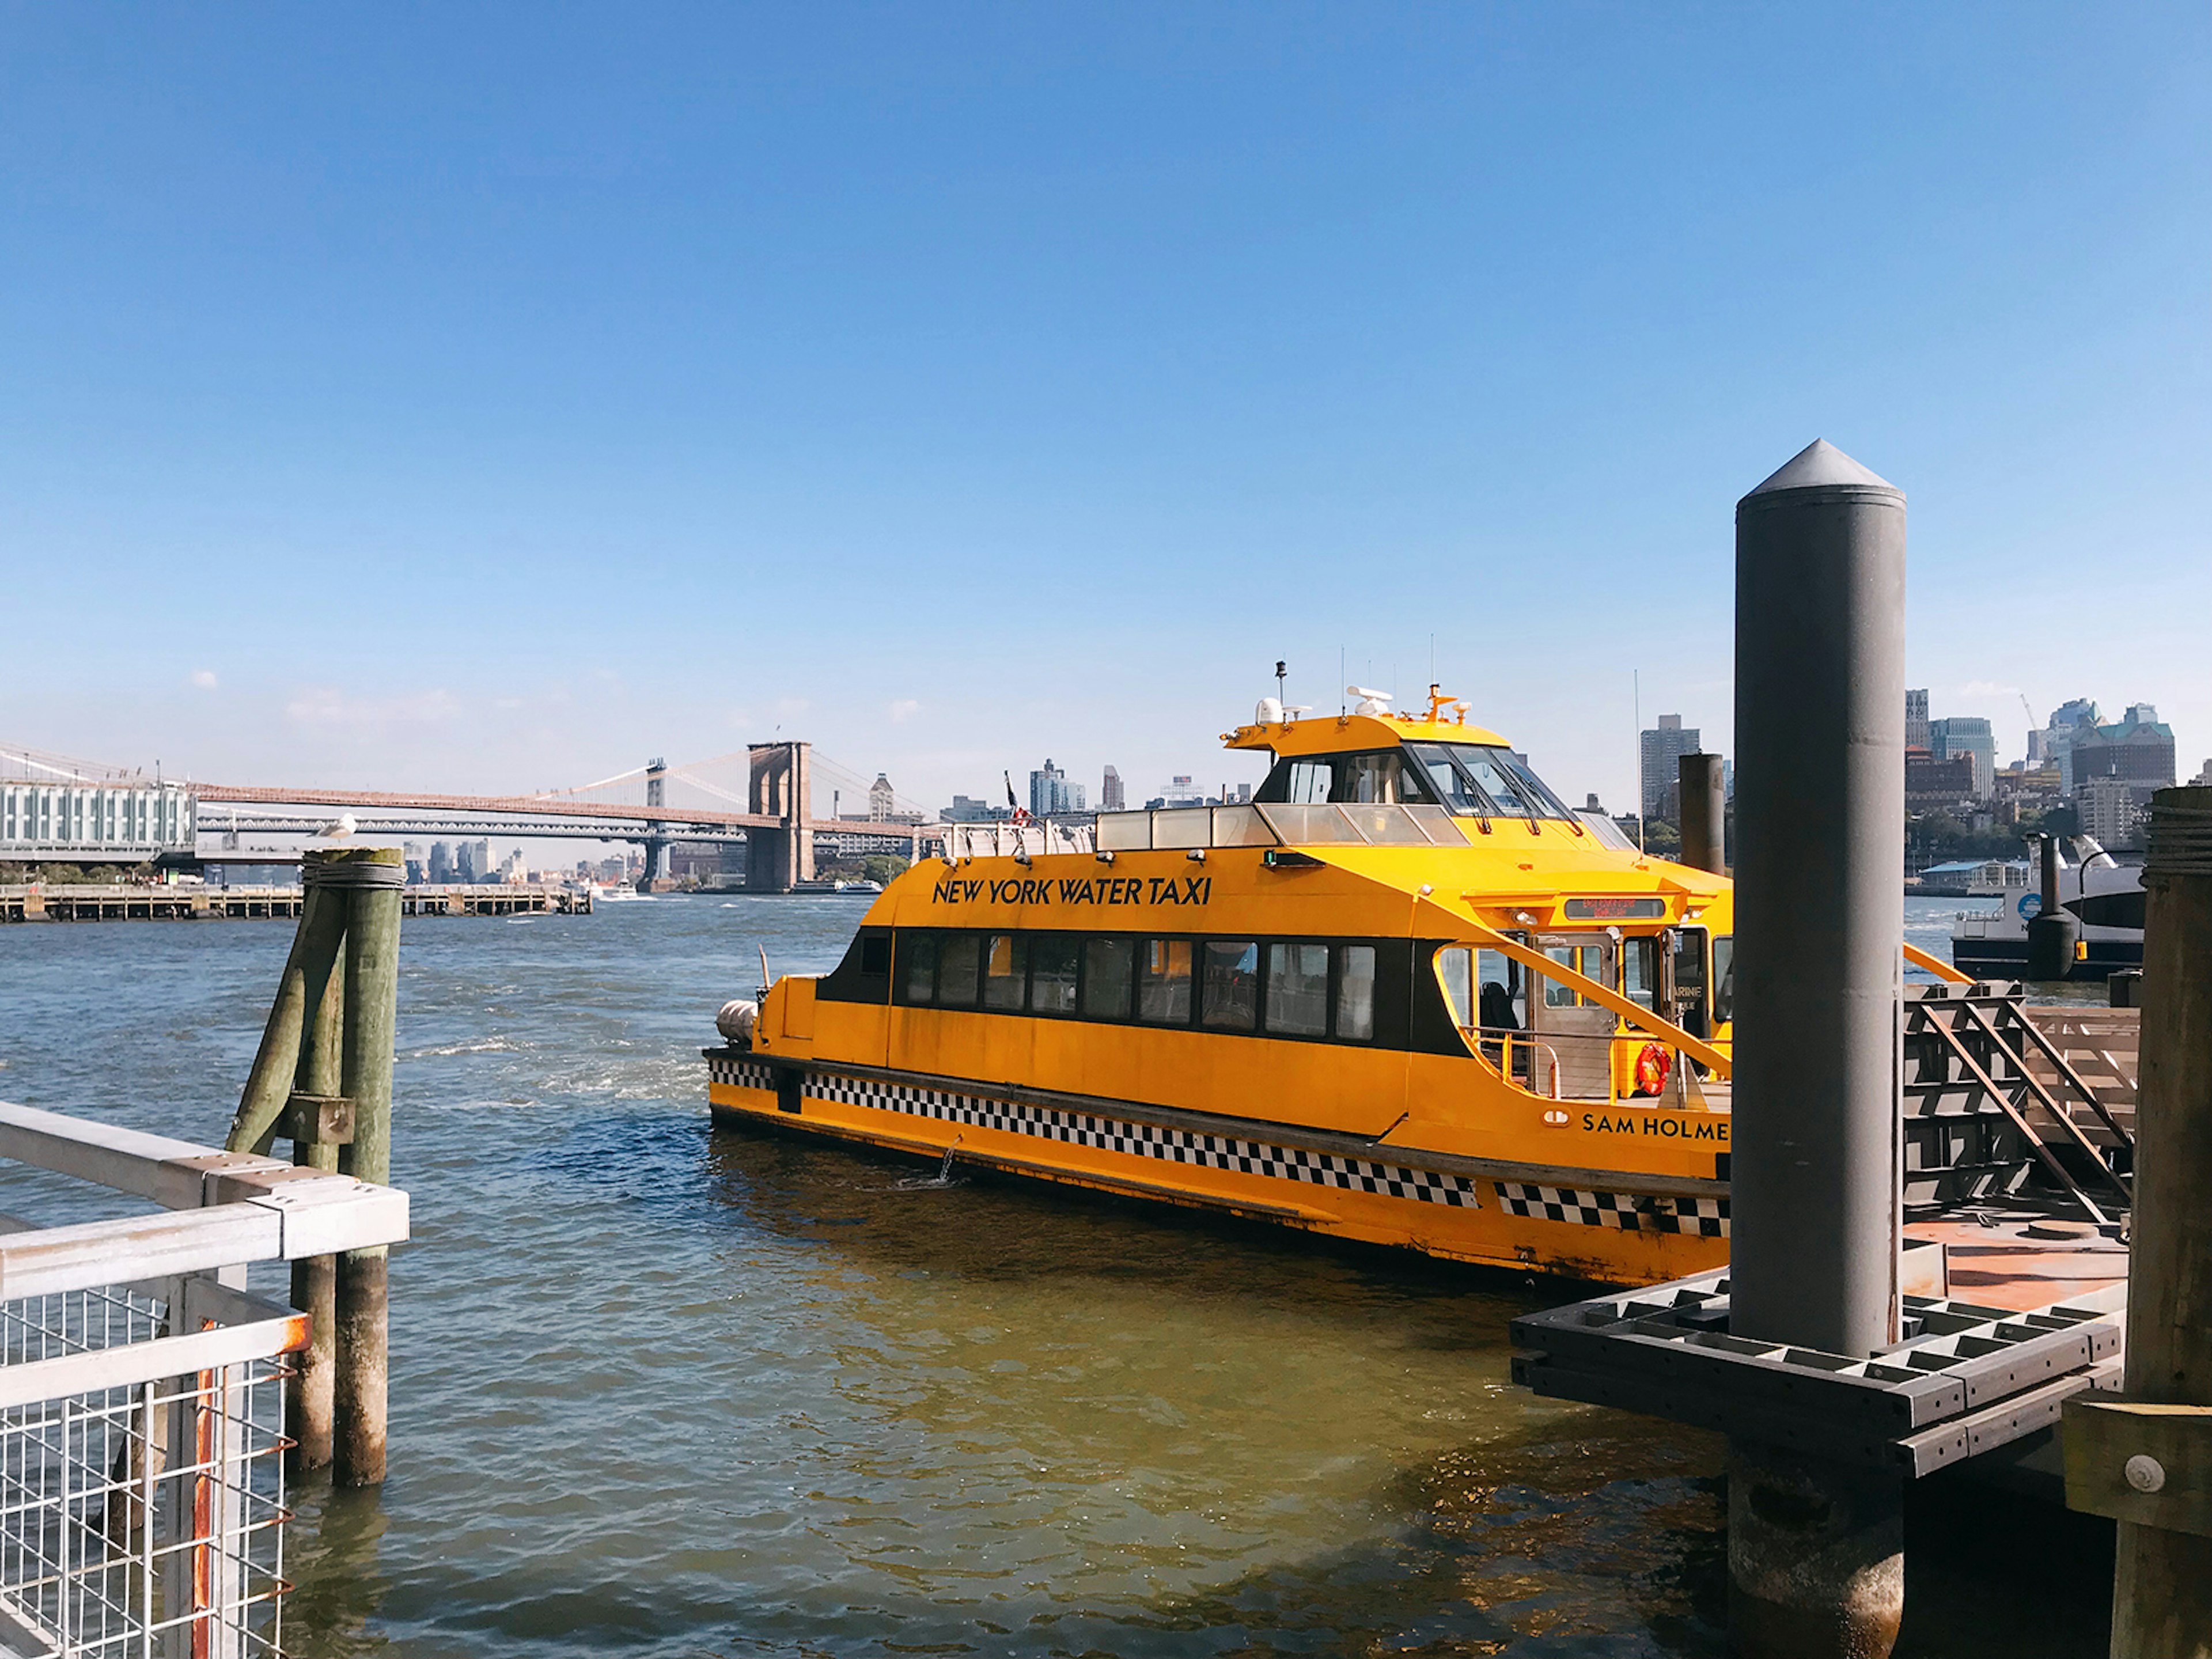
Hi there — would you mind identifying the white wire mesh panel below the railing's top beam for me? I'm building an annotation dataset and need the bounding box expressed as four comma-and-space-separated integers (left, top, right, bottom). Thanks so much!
0, 1277, 290, 1659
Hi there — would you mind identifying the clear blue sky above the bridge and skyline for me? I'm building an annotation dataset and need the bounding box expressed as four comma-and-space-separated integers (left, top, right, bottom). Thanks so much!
0, 5, 2212, 805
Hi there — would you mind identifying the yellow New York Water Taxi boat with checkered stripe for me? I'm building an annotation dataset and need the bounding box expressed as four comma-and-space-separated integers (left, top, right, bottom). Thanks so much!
706, 685, 1734, 1283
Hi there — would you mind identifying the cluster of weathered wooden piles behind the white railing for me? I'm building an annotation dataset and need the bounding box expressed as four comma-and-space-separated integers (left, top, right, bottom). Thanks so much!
226, 847, 407, 1486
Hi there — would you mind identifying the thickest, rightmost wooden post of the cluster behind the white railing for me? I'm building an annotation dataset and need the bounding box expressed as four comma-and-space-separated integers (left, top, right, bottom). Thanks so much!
332, 847, 407, 1486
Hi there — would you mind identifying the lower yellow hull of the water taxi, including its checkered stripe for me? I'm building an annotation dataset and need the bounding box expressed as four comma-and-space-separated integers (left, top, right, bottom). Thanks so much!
706, 1048, 1728, 1285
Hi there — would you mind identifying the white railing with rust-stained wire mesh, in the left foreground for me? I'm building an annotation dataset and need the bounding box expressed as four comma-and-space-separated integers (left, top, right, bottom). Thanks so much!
0, 1101, 407, 1659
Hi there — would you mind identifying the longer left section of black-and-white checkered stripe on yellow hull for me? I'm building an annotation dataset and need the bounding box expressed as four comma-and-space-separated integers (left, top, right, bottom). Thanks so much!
778, 1071, 1482, 1210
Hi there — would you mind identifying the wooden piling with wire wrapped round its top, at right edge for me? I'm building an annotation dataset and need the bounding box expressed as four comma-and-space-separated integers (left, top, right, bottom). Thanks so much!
2097, 787, 2212, 1659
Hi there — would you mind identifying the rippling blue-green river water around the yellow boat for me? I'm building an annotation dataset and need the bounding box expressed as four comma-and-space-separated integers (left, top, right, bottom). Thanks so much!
0, 896, 2110, 1659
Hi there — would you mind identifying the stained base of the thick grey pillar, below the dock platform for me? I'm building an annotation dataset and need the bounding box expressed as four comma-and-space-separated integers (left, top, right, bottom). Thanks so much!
1728, 1440, 1904, 1659
